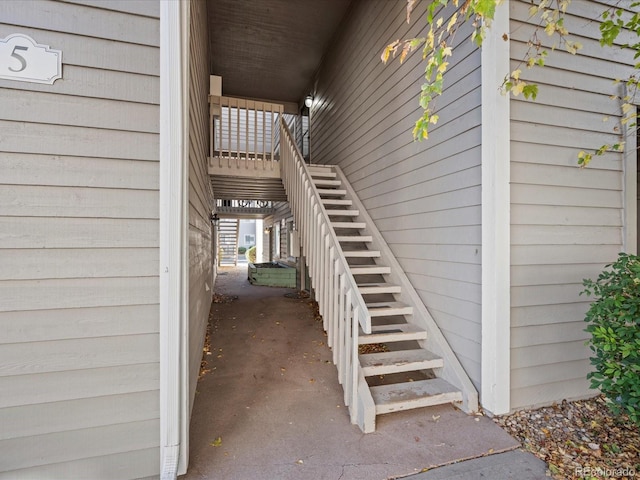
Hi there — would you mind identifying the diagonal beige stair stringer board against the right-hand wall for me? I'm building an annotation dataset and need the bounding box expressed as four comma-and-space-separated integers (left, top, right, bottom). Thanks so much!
331, 165, 478, 413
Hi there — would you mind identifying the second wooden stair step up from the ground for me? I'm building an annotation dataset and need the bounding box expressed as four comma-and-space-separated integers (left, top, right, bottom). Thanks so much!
358, 348, 444, 377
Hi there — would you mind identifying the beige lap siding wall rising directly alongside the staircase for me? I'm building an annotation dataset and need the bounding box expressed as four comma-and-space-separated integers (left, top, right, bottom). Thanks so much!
311, 1, 481, 386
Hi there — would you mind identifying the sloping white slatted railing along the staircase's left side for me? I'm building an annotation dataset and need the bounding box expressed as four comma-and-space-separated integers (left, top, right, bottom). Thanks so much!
280, 122, 371, 424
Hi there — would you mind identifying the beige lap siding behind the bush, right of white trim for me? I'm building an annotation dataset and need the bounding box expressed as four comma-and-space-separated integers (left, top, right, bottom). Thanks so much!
510, 1, 633, 409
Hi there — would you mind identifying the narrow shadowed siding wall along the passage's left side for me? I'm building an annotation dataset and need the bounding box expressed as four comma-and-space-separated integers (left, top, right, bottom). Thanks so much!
189, 1, 213, 414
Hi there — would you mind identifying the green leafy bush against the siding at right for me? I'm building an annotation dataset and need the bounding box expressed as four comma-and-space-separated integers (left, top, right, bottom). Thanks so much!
581, 253, 640, 425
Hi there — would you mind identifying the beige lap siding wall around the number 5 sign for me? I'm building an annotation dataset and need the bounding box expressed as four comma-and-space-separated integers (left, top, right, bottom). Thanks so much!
0, 0, 160, 479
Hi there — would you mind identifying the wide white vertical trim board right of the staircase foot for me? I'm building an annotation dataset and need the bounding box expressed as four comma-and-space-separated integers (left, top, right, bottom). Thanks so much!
480, 1, 511, 415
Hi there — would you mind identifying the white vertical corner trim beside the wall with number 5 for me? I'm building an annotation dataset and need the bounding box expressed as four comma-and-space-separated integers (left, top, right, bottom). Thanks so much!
159, 1, 189, 480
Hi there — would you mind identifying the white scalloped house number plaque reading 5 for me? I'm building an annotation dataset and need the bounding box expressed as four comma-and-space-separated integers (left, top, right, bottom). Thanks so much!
0, 33, 62, 85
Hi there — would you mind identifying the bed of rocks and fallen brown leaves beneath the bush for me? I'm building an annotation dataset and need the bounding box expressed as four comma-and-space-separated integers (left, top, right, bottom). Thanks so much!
494, 396, 640, 480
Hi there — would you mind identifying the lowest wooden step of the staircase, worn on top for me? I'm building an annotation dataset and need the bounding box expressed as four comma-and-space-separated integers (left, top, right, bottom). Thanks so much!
371, 378, 462, 415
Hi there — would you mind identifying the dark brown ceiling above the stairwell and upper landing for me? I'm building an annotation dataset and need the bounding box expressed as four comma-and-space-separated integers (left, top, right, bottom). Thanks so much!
208, 0, 352, 103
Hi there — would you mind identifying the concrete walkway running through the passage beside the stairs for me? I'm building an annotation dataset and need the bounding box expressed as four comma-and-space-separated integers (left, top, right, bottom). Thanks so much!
182, 266, 533, 480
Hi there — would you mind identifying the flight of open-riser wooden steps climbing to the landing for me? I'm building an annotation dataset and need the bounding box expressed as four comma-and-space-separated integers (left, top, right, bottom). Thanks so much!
308, 166, 470, 432
